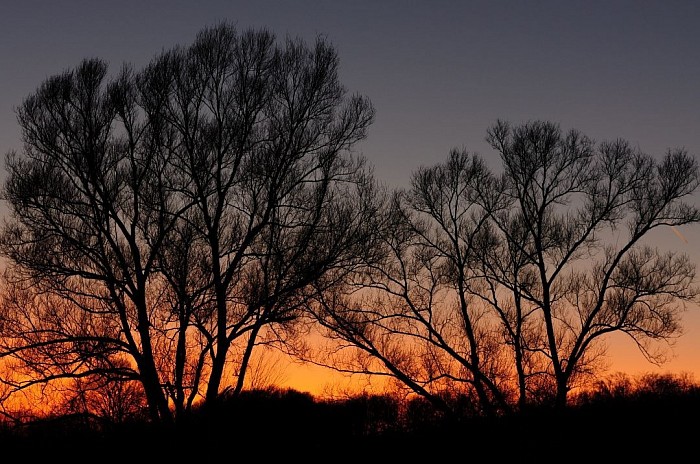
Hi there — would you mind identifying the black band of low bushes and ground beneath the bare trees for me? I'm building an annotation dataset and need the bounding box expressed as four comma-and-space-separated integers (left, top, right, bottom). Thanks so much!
0, 374, 700, 462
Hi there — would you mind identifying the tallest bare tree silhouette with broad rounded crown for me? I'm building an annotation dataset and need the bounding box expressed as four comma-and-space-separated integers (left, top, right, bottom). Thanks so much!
143, 25, 376, 410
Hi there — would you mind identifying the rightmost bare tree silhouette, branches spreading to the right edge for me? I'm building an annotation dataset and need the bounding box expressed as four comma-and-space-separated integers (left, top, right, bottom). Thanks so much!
485, 121, 700, 406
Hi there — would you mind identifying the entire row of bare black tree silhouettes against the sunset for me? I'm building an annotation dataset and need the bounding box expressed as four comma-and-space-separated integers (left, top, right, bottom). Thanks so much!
0, 23, 700, 433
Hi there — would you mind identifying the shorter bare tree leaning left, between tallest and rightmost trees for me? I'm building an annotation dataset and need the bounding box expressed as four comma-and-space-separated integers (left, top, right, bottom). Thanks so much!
308, 150, 509, 414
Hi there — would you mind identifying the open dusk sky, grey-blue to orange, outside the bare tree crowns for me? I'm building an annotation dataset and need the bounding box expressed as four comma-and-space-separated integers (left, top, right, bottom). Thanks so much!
0, 0, 700, 394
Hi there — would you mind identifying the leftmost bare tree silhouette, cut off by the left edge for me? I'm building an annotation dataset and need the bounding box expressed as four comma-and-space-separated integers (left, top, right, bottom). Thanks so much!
0, 60, 180, 421
